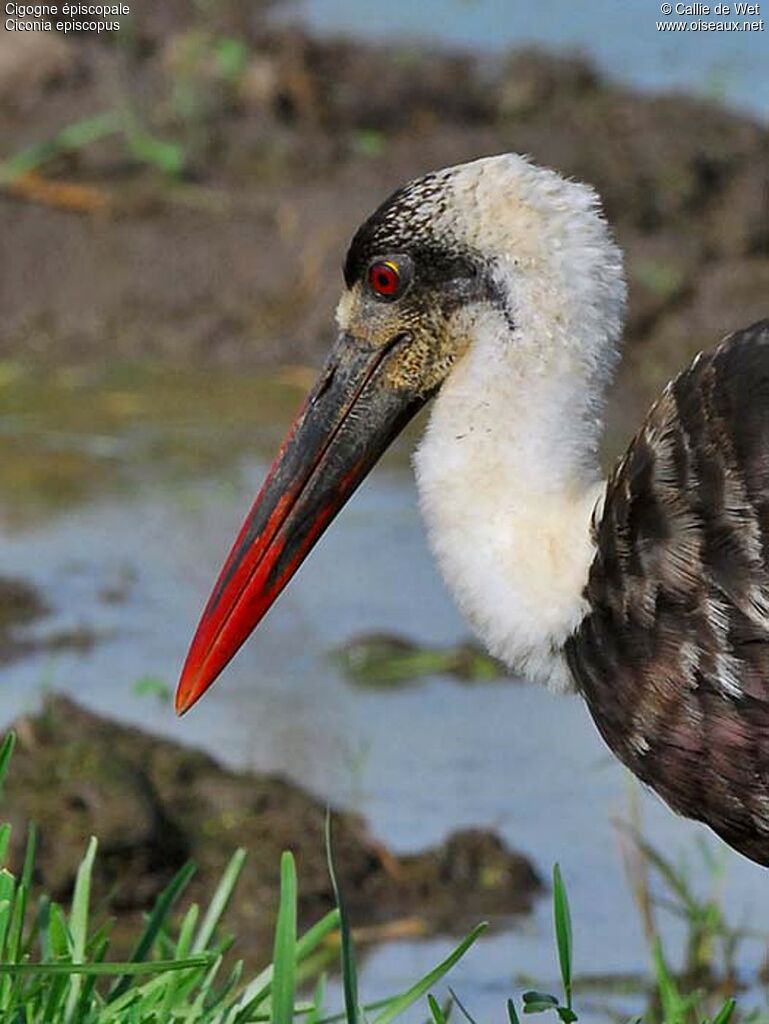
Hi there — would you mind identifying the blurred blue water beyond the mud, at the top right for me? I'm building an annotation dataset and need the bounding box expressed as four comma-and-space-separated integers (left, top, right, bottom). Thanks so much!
284, 0, 769, 120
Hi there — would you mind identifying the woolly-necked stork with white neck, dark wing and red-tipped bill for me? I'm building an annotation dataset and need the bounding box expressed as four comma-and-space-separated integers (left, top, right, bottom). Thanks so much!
176, 155, 769, 864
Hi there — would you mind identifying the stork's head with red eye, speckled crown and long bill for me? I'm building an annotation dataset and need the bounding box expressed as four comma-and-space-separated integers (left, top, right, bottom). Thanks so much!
176, 155, 622, 713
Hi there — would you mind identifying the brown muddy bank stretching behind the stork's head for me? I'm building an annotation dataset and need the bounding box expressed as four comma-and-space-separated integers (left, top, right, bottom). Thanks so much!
0, 8, 769, 415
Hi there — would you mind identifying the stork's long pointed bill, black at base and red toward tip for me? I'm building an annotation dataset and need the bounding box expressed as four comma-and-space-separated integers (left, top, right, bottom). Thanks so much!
176, 334, 426, 714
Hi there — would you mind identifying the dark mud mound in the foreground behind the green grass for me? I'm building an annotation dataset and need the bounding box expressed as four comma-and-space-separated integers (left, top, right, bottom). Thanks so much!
2, 696, 542, 955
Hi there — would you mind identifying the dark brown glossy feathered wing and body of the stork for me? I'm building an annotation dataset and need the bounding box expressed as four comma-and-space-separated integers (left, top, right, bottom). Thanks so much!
566, 321, 769, 864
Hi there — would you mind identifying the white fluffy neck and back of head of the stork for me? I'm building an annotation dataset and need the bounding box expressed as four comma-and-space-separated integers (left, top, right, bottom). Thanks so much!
415, 157, 625, 689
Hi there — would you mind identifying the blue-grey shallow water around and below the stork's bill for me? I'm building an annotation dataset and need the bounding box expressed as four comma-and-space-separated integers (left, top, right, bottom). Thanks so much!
0, 372, 769, 1020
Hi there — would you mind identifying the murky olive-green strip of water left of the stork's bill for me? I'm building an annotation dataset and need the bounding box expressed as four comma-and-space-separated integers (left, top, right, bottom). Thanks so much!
0, 362, 311, 526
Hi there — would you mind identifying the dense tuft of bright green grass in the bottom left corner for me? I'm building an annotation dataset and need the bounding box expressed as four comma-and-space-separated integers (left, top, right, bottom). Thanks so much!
0, 733, 483, 1024
